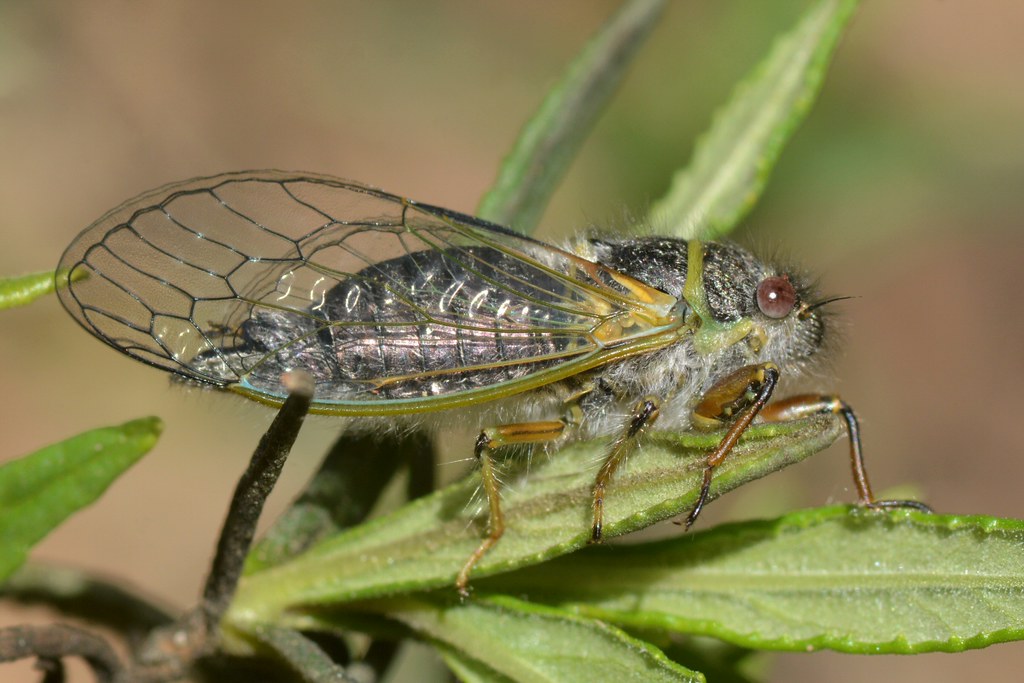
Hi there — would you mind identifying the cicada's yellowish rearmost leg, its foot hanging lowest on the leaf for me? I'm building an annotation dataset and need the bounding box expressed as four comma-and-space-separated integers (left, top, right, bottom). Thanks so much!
455, 420, 565, 597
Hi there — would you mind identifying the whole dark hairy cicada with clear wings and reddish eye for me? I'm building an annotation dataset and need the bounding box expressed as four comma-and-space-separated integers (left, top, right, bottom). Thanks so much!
58, 171, 923, 592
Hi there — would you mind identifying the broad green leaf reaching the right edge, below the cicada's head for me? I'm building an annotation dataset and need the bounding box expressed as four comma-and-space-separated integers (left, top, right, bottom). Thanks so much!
479, 507, 1024, 653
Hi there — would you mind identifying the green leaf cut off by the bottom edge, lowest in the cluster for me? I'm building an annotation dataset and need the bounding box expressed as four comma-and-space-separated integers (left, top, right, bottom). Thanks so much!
346, 597, 705, 683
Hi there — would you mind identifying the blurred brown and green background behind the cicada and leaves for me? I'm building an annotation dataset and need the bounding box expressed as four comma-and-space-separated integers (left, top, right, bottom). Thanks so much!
0, 0, 1024, 683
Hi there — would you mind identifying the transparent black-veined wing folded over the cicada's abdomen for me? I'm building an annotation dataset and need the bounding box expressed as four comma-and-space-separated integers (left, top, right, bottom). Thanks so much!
58, 171, 678, 415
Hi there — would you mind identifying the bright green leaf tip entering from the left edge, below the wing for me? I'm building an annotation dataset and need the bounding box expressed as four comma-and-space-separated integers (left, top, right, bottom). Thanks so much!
0, 418, 163, 581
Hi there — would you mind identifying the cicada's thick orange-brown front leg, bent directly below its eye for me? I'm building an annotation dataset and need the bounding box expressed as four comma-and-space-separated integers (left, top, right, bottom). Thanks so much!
683, 362, 779, 528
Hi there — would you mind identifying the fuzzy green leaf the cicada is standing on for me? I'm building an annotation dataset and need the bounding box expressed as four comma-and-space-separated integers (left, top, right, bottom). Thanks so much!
226, 416, 843, 623
